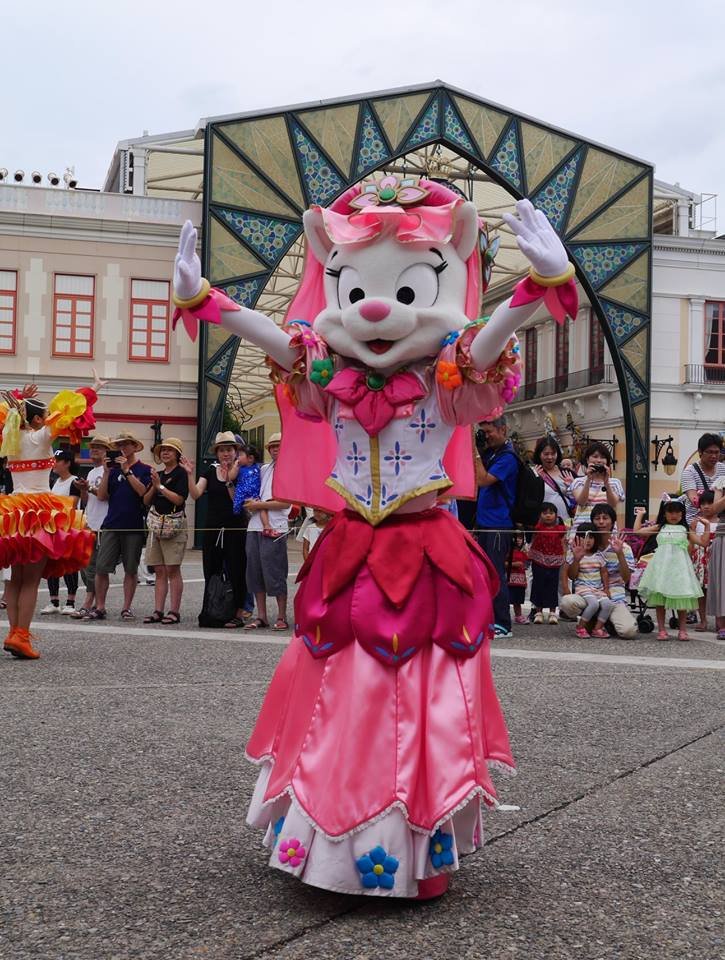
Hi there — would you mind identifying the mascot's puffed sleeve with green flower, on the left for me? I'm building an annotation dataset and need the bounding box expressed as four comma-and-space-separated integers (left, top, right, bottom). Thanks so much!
267, 320, 335, 420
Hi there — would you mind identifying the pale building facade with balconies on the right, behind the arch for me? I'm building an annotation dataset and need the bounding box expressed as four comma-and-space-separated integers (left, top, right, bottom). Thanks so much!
508, 181, 725, 513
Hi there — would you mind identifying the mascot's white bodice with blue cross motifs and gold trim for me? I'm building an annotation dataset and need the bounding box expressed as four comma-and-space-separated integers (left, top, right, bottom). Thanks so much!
327, 391, 455, 524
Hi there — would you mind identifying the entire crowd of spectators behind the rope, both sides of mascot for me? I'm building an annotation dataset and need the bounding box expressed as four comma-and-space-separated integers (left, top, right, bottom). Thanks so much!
0, 417, 725, 639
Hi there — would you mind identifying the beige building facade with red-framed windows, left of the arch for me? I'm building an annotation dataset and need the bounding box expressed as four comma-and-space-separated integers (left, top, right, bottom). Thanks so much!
0, 184, 200, 468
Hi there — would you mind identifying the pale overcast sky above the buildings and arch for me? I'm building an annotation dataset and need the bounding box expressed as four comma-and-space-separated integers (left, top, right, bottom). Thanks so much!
5, 0, 725, 230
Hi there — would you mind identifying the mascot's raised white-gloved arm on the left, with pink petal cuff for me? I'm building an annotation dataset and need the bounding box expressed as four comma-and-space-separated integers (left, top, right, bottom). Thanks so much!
174, 220, 297, 370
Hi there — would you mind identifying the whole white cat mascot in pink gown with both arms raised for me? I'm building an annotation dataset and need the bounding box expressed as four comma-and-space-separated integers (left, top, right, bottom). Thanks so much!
174, 177, 576, 898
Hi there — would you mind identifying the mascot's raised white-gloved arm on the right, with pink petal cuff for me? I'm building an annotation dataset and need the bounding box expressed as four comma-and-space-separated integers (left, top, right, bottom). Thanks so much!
471, 200, 578, 371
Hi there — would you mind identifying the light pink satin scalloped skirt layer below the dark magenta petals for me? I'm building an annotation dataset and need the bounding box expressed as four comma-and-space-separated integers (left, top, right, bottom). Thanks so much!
247, 637, 513, 839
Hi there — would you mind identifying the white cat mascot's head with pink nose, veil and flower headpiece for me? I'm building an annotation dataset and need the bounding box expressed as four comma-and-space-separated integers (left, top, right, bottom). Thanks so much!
287, 176, 481, 372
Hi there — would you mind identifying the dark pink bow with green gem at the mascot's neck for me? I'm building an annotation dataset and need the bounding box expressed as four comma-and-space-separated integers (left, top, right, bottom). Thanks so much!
325, 367, 425, 437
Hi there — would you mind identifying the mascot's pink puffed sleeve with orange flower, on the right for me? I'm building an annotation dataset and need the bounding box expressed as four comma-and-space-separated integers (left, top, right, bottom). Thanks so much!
433, 320, 521, 426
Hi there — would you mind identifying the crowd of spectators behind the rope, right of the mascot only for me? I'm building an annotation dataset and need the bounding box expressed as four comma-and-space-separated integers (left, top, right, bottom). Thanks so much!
475, 417, 725, 639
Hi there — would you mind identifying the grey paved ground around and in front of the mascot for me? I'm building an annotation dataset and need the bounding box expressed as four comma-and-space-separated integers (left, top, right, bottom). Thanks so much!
0, 555, 725, 960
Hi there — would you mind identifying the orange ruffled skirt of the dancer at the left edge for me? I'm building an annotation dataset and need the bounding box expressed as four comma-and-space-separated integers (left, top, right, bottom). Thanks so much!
0, 493, 96, 577
